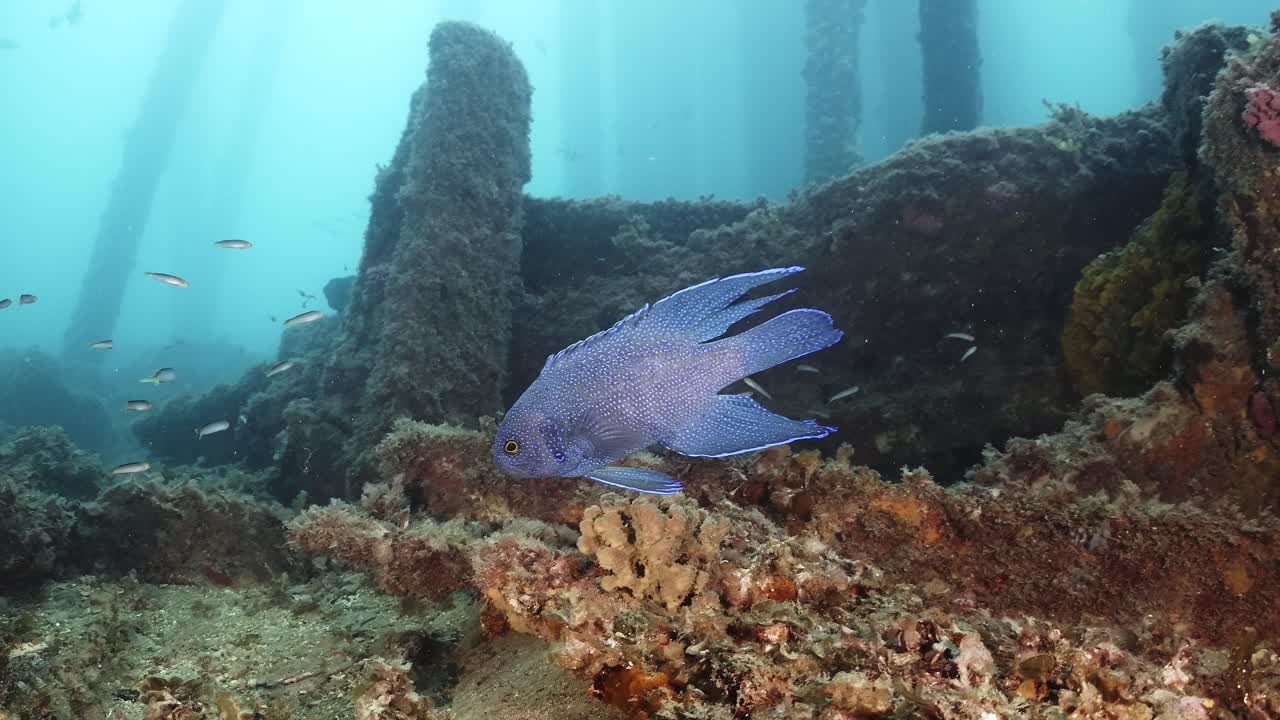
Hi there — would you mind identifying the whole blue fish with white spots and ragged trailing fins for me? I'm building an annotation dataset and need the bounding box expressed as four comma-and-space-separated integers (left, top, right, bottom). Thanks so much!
493, 268, 844, 495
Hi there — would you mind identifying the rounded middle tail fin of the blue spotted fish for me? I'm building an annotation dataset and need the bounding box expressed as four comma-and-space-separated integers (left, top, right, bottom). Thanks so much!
712, 307, 845, 386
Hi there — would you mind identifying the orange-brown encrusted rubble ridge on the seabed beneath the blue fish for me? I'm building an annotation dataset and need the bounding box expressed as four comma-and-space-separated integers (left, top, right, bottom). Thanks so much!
291, 440, 1280, 719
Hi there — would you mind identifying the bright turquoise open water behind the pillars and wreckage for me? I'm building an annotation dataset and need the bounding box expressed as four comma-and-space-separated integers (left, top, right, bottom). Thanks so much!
0, 0, 1272, 397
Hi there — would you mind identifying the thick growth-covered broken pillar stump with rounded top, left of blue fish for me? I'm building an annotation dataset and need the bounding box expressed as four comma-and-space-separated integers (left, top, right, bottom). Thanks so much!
324, 22, 532, 475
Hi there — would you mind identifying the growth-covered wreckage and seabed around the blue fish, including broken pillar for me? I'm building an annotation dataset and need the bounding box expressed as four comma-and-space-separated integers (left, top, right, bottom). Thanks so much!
0, 15, 1280, 720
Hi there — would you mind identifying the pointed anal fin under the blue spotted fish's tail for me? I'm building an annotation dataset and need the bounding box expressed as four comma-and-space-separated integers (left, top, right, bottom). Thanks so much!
663, 395, 835, 457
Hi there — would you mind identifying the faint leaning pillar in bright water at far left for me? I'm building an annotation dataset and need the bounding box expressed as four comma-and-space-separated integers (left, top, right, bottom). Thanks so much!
63, 0, 225, 360
